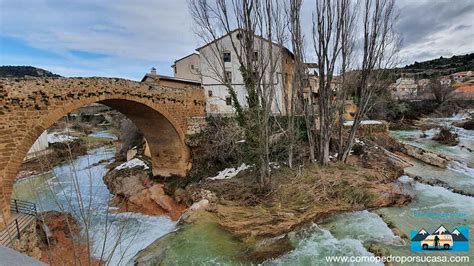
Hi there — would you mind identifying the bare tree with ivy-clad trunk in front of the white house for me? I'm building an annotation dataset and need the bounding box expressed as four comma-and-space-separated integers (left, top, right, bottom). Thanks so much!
188, 0, 286, 188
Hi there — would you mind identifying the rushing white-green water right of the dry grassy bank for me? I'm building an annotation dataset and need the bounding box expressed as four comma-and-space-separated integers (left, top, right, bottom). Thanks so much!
268, 115, 474, 265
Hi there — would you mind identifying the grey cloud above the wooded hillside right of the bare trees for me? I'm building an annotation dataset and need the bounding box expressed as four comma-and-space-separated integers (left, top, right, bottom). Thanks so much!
396, 0, 474, 64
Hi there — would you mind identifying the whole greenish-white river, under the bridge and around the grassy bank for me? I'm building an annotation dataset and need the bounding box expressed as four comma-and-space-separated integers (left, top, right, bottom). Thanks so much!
15, 115, 474, 265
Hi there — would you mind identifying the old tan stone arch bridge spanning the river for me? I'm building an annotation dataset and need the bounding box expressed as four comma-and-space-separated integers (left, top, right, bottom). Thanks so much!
0, 78, 205, 228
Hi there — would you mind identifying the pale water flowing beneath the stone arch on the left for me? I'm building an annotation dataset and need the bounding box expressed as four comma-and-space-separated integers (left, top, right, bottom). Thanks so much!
13, 143, 176, 265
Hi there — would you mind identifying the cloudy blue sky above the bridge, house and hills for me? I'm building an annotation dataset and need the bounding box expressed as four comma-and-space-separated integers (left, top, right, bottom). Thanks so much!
0, 0, 474, 80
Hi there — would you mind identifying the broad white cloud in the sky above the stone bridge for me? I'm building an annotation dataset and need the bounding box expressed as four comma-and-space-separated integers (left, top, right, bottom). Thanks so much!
0, 0, 196, 79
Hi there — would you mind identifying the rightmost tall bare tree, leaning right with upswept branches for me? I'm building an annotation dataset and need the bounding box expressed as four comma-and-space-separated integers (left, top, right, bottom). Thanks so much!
342, 0, 399, 161
